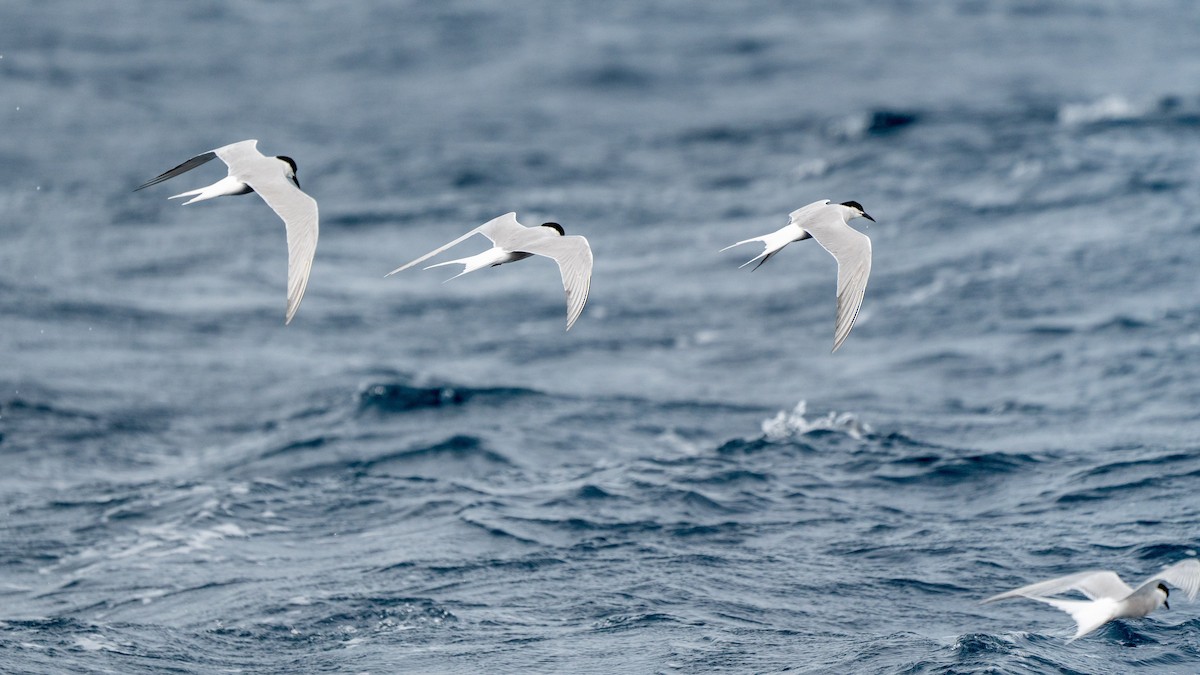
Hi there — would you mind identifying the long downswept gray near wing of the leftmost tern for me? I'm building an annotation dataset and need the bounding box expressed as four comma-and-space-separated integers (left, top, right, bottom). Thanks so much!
238, 163, 318, 323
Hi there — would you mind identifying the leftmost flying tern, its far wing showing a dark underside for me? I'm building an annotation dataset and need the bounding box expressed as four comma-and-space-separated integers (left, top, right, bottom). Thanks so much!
134, 141, 317, 324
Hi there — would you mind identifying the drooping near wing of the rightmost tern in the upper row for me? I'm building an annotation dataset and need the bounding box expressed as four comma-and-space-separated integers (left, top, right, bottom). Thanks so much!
792, 204, 871, 352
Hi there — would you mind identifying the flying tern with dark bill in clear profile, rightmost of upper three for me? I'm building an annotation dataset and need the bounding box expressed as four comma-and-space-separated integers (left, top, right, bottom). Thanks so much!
721, 199, 875, 352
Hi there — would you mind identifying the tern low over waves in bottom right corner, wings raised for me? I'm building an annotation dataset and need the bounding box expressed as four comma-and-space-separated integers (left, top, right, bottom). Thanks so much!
983, 557, 1200, 640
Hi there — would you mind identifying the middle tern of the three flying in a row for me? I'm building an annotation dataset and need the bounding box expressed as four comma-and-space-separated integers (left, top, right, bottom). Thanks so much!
386, 213, 592, 330
